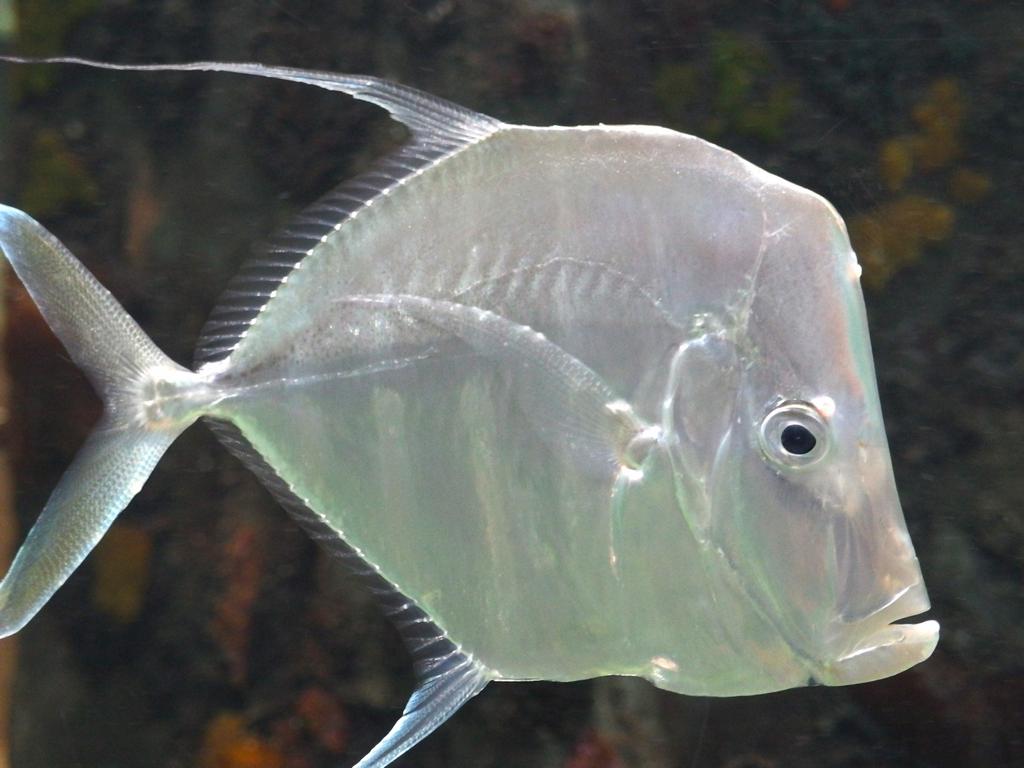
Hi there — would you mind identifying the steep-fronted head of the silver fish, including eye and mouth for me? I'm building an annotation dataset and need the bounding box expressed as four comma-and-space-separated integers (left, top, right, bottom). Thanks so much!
708, 183, 938, 685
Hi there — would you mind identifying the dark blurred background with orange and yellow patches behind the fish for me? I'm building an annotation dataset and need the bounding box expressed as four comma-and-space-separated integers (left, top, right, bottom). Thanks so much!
0, 0, 1024, 768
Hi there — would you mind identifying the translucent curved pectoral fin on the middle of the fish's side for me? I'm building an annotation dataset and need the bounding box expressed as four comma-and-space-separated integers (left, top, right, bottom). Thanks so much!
338, 295, 656, 479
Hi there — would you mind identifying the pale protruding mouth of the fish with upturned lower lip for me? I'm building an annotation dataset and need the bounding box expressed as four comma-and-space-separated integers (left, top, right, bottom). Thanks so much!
819, 583, 939, 685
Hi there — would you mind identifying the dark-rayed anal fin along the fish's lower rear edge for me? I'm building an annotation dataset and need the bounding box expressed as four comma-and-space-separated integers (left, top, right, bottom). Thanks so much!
206, 419, 492, 768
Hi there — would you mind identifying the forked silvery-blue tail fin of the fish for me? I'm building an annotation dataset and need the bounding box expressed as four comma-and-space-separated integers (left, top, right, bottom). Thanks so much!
0, 205, 199, 637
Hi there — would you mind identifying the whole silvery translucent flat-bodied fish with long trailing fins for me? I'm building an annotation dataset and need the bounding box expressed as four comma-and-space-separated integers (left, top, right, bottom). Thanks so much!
0, 58, 939, 768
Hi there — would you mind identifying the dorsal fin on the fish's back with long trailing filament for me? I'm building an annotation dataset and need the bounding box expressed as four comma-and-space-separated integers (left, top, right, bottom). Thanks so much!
0, 56, 504, 366
